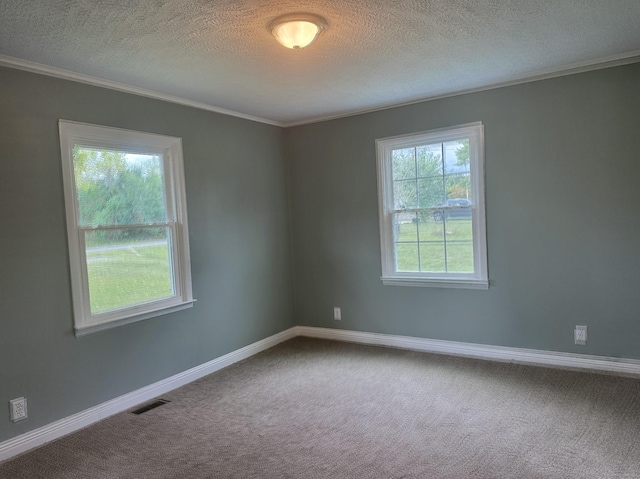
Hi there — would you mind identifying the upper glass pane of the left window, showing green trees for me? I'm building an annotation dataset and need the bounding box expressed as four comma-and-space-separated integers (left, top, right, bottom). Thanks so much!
73, 145, 167, 227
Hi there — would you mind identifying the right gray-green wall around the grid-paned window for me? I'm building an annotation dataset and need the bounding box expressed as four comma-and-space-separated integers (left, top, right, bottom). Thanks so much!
286, 64, 640, 358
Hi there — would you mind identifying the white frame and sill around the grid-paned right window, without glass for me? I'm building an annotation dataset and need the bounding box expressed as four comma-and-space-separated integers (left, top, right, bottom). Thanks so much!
376, 122, 489, 289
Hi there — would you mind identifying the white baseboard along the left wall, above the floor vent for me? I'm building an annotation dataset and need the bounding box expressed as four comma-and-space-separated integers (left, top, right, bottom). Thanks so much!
0, 328, 296, 462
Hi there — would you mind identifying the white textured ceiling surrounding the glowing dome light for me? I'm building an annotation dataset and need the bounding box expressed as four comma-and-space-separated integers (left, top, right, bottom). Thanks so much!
0, 0, 640, 125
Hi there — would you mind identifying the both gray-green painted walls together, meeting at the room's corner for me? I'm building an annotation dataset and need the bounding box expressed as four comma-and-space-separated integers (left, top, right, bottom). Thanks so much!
0, 60, 640, 441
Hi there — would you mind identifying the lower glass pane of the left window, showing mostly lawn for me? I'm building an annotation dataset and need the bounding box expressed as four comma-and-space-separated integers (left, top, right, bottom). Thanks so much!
85, 227, 174, 314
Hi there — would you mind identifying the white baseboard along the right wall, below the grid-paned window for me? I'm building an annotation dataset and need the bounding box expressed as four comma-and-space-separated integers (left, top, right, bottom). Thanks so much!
293, 326, 640, 376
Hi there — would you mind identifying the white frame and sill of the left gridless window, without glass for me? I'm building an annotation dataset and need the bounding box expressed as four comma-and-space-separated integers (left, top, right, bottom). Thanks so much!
59, 120, 195, 336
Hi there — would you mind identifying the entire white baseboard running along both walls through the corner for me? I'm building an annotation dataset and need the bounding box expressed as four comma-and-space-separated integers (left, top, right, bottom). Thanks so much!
0, 326, 640, 461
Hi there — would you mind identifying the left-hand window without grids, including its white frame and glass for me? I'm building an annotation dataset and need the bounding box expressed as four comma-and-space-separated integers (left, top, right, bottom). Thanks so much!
59, 120, 193, 335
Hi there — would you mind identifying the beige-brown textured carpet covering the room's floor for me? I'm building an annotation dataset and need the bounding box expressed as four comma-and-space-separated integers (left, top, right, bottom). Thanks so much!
0, 338, 640, 479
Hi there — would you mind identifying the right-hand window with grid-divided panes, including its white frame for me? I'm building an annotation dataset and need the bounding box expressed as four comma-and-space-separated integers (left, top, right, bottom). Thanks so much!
376, 123, 489, 289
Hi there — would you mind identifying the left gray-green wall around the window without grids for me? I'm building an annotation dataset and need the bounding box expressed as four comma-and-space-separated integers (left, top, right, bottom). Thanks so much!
0, 69, 294, 441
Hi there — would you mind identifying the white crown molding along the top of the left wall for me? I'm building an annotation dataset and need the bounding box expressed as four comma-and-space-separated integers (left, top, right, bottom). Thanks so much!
0, 54, 283, 127
